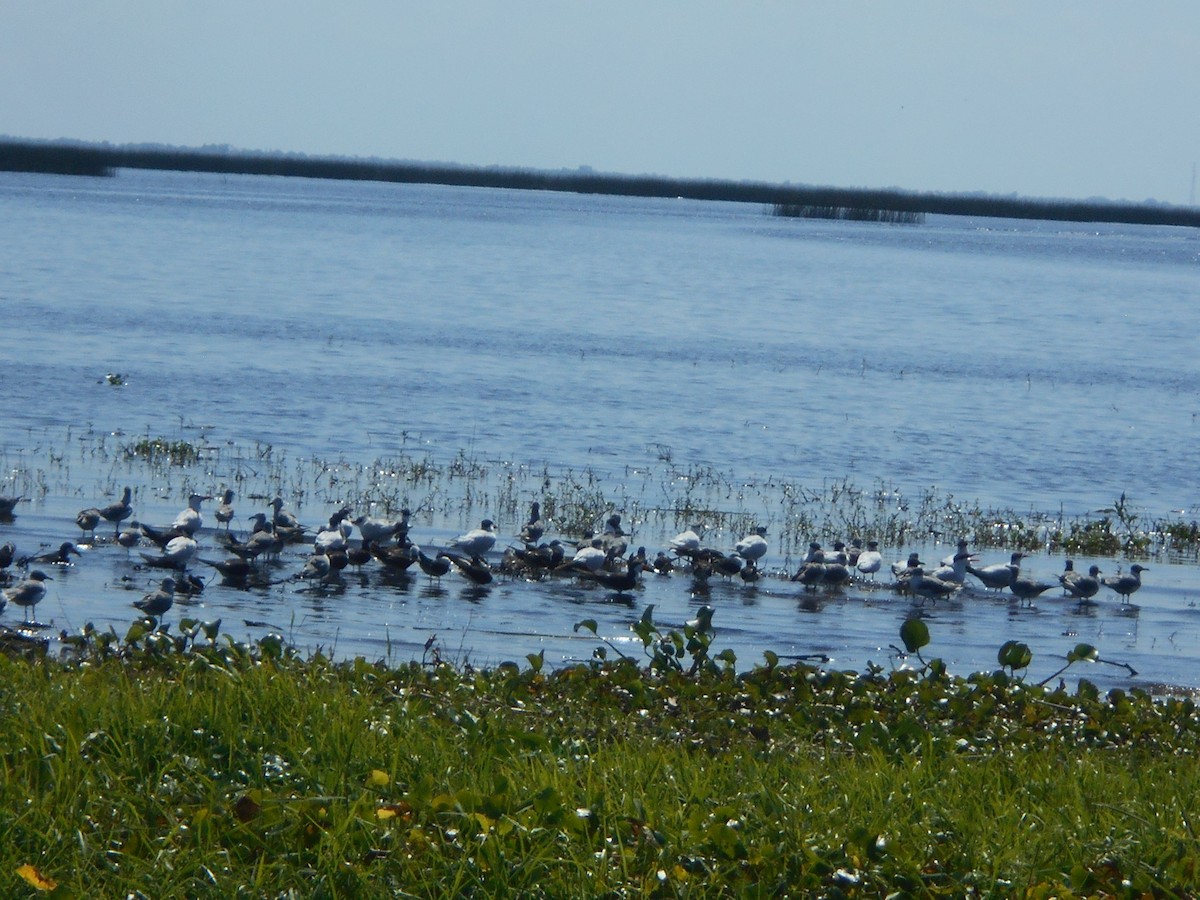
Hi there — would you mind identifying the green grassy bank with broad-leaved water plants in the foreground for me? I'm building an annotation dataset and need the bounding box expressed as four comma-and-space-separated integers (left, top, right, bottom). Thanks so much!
0, 617, 1200, 898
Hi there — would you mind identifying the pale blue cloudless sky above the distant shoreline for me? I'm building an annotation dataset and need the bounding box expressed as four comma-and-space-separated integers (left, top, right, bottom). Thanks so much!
0, 0, 1200, 204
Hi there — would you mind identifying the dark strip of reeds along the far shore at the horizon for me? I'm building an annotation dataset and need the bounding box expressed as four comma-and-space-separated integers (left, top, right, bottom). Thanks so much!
0, 139, 1200, 227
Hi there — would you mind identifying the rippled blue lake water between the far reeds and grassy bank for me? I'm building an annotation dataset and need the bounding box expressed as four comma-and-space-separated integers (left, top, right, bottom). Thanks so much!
0, 170, 1200, 688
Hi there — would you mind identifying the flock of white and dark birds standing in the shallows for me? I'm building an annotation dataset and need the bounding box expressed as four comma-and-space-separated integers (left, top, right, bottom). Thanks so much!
0, 487, 1147, 624
